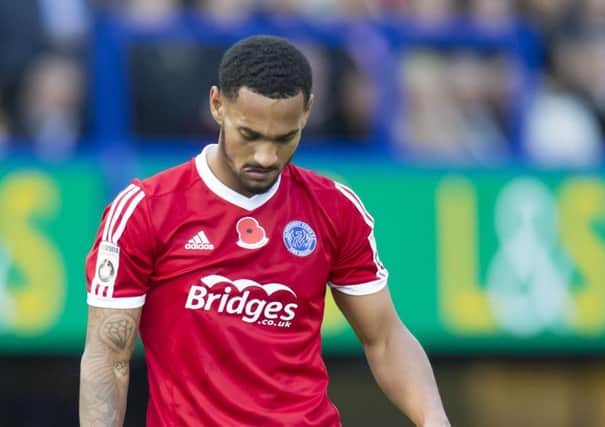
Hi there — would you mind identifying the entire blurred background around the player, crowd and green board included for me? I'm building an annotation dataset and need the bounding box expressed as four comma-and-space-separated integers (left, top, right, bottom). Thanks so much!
0, 0, 605, 427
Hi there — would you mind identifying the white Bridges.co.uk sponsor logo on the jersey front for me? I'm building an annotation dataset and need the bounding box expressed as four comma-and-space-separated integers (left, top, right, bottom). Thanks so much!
185, 274, 298, 328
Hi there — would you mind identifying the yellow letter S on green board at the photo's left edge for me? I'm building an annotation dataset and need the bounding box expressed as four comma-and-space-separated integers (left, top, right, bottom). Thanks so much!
0, 171, 65, 335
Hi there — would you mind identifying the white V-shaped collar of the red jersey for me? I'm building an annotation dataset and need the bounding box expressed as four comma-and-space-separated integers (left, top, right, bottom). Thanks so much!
195, 144, 281, 211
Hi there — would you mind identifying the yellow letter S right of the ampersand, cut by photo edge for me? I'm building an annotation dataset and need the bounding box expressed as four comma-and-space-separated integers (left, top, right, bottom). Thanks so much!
559, 178, 605, 335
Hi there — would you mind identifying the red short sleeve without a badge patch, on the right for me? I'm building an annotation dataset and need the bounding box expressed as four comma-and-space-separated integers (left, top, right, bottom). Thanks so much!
328, 183, 388, 295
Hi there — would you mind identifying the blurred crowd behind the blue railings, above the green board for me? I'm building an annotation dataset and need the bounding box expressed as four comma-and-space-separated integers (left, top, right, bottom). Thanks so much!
0, 0, 605, 167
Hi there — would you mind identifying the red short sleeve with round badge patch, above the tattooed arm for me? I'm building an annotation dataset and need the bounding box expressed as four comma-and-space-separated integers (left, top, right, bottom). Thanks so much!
86, 181, 153, 308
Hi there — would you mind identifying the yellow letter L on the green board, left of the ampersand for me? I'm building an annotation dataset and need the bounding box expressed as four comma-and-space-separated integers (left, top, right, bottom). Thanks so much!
436, 177, 497, 334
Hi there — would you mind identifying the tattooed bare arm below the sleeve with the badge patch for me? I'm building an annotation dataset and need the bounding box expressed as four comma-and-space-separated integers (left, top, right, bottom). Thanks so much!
80, 307, 141, 427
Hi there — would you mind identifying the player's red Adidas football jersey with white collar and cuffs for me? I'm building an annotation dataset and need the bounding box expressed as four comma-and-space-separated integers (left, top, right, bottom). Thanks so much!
86, 145, 387, 427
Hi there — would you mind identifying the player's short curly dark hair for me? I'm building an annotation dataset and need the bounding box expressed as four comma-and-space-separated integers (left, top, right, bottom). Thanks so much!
219, 35, 313, 104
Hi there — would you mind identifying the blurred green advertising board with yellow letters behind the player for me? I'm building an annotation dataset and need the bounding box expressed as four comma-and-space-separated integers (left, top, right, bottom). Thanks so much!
0, 157, 605, 354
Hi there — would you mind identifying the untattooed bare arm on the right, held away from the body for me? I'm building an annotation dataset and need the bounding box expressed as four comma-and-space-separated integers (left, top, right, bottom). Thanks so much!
332, 288, 450, 427
